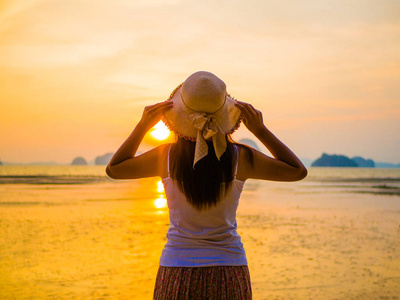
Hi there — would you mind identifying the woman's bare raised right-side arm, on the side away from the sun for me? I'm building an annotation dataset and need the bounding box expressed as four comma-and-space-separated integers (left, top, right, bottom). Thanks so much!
236, 101, 307, 181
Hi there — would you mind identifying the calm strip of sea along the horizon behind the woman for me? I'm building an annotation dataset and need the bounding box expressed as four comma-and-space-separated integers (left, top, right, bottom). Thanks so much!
0, 166, 400, 198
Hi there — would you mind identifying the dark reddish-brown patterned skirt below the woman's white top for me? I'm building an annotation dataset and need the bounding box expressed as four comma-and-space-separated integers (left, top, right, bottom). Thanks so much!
153, 266, 252, 300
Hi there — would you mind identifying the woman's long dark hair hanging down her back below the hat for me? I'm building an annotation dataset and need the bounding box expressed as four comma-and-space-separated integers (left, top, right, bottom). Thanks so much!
170, 135, 253, 210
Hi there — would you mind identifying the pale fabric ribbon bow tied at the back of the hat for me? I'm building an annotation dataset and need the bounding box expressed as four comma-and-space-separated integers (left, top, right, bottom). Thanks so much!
188, 113, 226, 168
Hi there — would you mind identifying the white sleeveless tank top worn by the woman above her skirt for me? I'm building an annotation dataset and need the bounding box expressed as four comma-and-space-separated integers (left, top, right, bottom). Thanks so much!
160, 147, 247, 267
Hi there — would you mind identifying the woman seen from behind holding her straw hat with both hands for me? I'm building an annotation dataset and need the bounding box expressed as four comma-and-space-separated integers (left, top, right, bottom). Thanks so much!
106, 72, 307, 299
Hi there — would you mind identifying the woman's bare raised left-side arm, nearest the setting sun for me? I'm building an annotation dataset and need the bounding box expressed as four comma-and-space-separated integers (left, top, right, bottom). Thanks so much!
106, 102, 172, 179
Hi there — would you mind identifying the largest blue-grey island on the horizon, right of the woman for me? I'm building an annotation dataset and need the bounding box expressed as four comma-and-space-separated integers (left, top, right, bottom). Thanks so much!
311, 153, 375, 168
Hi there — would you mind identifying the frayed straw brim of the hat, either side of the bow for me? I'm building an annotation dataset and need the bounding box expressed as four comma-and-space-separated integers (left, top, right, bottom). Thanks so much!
162, 85, 242, 140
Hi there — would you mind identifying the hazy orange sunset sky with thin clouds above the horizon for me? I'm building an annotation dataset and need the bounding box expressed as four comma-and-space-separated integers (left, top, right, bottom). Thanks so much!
0, 0, 400, 163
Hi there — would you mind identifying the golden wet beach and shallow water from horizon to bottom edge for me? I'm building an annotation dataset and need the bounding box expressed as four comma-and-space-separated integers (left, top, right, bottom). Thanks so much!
0, 166, 400, 299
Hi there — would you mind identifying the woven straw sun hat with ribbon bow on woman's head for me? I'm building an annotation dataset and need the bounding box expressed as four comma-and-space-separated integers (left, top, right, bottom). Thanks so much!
163, 71, 241, 167
